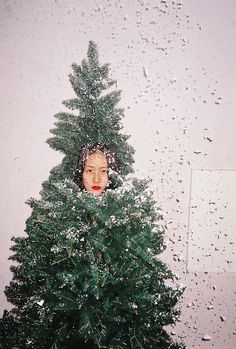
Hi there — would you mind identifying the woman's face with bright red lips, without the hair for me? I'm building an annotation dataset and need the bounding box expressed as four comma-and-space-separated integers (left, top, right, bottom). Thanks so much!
83, 150, 108, 196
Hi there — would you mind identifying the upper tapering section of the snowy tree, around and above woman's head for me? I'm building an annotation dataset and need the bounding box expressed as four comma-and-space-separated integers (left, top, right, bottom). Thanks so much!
47, 41, 134, 182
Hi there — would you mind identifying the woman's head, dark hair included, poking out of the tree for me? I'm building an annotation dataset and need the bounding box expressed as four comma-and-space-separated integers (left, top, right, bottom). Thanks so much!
74, 142, 118, 196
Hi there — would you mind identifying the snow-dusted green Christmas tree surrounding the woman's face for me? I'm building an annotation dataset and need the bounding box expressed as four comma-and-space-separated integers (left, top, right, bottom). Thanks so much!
0, 42, 184, 349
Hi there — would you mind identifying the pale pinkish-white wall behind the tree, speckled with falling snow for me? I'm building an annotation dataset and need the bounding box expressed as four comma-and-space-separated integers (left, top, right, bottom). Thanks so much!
0, 0, 236, 349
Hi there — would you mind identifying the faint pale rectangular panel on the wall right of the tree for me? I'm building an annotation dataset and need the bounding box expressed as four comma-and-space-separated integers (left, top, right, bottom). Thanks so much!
186, 169, 236, 272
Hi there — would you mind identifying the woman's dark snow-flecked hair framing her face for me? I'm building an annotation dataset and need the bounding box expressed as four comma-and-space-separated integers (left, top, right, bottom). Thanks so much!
74, 142, 119, 189
